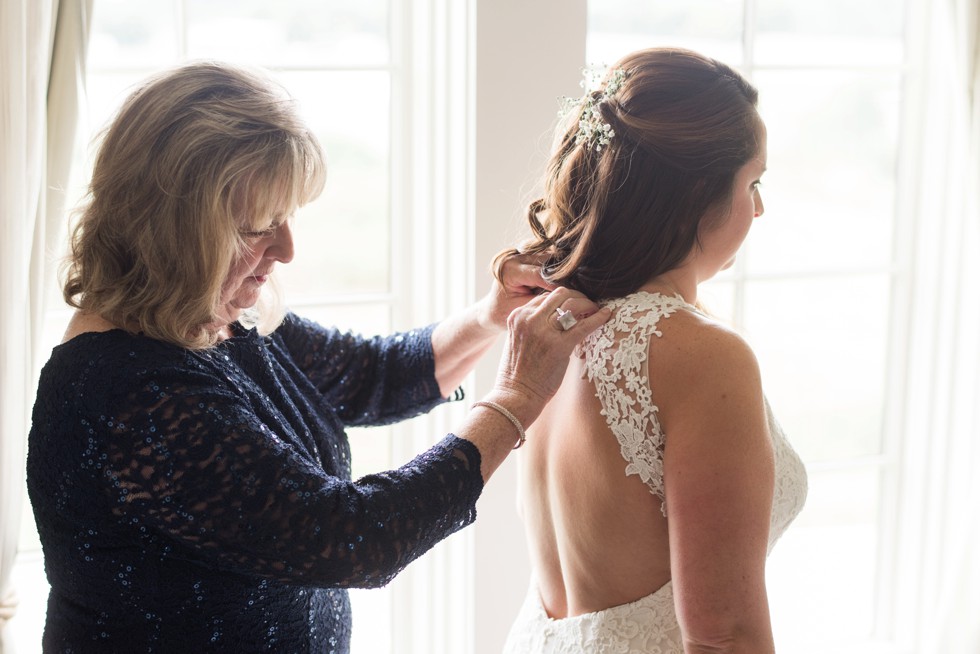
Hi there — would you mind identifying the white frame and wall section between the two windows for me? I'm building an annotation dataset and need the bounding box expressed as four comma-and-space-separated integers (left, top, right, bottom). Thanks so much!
392, 0, 586, 654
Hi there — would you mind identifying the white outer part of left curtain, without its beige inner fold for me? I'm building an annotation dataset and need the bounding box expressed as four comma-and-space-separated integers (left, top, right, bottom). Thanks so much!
0, 0, 56, 652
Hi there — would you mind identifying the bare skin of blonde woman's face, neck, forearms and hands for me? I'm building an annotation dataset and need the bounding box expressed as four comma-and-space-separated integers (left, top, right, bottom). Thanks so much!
63, 214, 611, 482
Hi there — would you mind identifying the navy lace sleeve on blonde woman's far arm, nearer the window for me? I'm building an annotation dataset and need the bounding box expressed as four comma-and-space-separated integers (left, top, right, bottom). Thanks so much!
271, 314, 445, 425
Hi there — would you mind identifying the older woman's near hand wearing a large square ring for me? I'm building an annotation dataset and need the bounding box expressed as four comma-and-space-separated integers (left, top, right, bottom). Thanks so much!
492, 287, 612, 418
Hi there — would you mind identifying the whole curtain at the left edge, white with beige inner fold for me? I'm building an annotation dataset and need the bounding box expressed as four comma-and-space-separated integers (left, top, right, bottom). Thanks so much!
0, 0, 92, 654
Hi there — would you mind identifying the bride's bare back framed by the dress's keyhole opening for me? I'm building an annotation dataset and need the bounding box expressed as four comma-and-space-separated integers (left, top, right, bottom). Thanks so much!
520, 348, 670, 618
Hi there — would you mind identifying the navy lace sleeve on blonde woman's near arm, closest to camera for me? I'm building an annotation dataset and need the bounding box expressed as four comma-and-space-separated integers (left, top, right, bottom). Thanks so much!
99, 370, 482, 587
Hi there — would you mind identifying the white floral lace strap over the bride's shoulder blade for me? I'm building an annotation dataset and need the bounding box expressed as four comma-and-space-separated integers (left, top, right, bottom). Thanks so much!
582, 292, 694, 515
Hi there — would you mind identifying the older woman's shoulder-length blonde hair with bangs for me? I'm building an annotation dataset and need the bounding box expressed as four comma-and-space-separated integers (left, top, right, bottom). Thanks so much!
63, 62, 326, 349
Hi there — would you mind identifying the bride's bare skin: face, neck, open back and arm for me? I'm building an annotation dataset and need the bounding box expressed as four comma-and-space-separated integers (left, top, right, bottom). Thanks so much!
520, 129, 774, 654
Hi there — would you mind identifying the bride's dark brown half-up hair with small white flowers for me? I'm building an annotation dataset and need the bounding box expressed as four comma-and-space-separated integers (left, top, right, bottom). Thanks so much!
494, 48, 761, 299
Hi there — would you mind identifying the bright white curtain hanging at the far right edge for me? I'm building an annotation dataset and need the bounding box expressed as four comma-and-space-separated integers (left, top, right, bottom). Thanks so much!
919, 0, 980, 654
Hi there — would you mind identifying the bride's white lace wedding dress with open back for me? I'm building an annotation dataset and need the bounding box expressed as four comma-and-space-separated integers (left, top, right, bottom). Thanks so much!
504, 292, 807, 654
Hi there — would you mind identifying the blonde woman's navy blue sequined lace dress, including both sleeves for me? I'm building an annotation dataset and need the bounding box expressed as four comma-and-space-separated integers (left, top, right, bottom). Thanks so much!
27, 314, 483, 654
